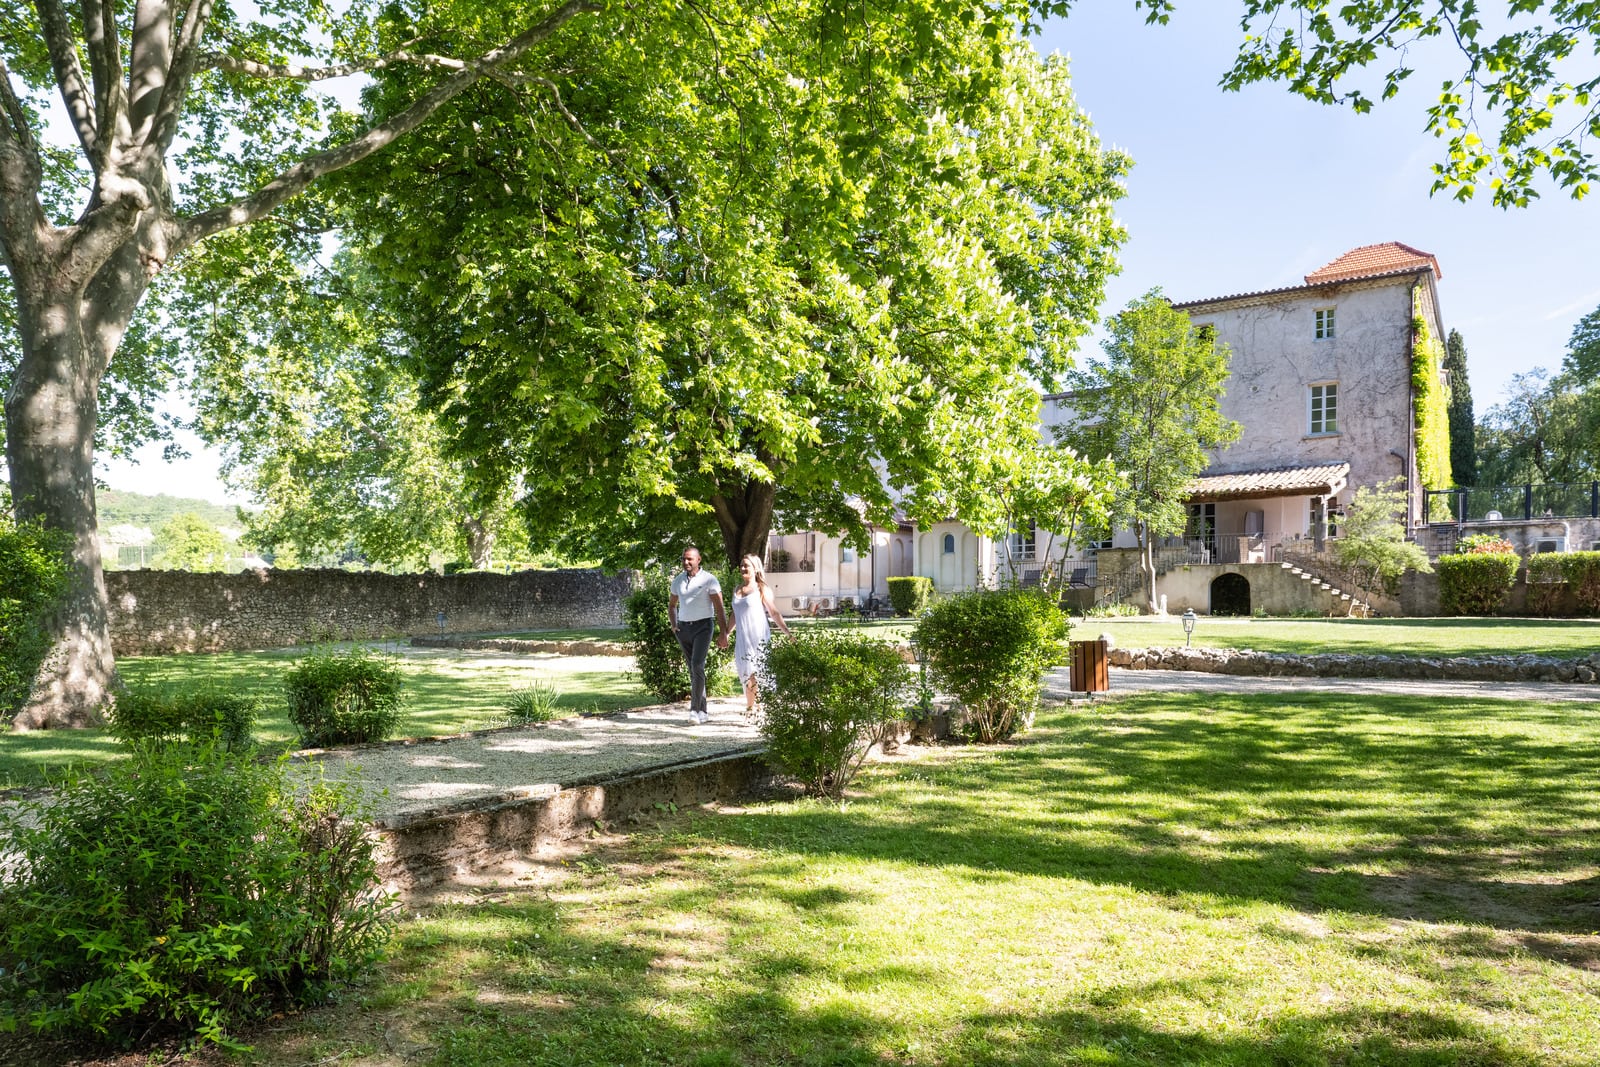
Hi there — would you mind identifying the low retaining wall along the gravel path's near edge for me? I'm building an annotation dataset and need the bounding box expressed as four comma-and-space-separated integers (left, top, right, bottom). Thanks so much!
374, 753, 771, 897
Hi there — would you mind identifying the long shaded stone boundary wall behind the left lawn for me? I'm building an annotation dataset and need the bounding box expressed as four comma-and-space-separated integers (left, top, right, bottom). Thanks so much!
106, 569, 632, 656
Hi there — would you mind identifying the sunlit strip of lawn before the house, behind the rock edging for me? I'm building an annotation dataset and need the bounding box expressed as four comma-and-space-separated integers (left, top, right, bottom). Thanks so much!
1072, 616, 1600, 657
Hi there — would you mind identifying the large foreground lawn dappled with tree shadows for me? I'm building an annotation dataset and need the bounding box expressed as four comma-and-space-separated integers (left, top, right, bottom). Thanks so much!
218, 696, 1600, 1067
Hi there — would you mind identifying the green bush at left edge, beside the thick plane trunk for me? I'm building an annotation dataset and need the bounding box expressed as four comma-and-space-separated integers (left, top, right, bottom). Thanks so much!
0, 517, 70, 723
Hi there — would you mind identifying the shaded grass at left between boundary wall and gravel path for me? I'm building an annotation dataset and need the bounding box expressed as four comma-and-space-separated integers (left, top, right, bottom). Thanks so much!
0, 649, 656, 789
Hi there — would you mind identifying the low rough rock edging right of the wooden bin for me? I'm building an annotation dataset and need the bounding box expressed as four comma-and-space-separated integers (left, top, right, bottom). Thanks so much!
1109, 648, 1600, 681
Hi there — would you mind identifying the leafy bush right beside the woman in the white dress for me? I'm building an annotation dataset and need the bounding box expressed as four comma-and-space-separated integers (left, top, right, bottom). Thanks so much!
762, 627, 912, 800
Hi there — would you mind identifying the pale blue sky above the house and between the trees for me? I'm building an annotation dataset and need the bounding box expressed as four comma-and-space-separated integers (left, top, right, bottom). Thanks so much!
102, 0, 1600, 501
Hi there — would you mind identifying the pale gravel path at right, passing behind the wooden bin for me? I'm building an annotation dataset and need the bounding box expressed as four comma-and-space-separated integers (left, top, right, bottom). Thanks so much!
1046, 667, 1600, 701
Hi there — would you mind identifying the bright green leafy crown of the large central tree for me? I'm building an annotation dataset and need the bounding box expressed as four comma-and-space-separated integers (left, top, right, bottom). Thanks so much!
336, 5, 1126, 565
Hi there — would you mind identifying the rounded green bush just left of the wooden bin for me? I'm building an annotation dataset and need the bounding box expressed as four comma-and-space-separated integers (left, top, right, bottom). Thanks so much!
915, 589, 1067, 744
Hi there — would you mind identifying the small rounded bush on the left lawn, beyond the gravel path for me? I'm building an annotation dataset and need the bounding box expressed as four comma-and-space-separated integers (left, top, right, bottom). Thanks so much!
283, 646, 403, 749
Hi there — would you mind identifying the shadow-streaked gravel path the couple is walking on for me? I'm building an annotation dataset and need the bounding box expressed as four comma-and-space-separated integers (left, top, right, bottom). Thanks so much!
312, 697, 760, 817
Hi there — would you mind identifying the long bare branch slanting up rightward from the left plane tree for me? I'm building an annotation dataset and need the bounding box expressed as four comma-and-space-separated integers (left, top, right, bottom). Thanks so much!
171, 0, 603, 254
